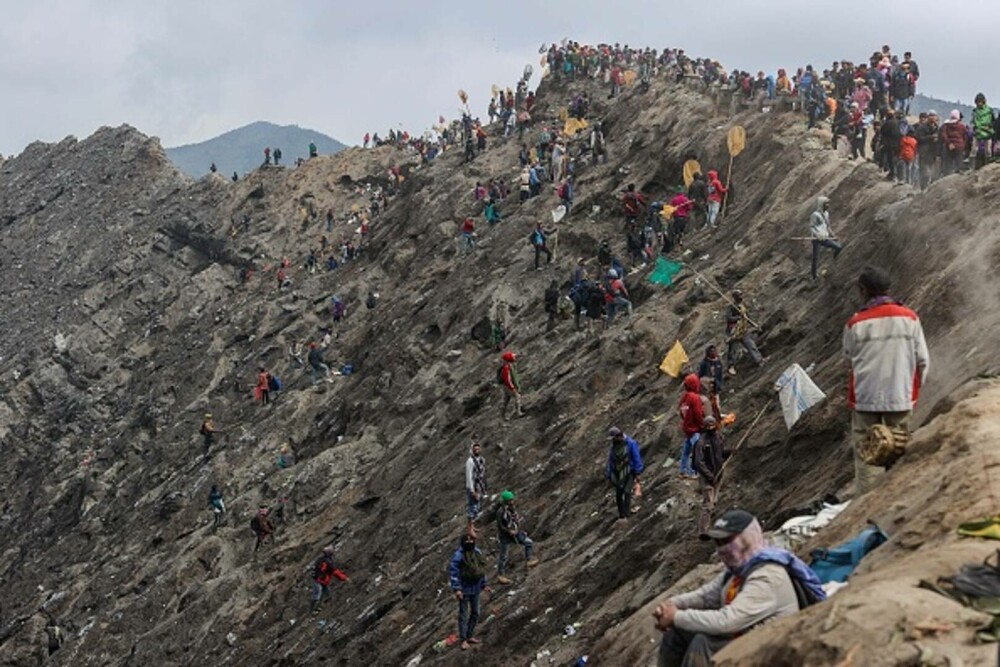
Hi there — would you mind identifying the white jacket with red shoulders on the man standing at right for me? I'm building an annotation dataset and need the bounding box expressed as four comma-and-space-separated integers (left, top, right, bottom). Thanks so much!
844, 297, 930, 412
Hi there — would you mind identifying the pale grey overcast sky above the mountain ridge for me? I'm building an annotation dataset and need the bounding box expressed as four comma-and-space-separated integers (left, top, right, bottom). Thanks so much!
0, 0, 1000, 155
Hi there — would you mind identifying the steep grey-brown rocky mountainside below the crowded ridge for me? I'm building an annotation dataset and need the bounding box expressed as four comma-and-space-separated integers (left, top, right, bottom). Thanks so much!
0, 64, 1000, 665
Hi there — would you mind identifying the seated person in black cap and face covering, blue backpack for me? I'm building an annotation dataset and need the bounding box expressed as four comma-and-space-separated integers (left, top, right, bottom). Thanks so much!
653, 509, 826, 667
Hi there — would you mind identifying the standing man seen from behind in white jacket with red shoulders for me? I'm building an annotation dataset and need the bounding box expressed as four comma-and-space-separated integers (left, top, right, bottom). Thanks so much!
843, 267, 930, 496
